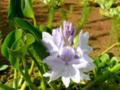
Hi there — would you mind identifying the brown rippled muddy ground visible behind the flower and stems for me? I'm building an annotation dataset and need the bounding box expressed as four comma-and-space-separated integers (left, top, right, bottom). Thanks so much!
0, 0, 120, 84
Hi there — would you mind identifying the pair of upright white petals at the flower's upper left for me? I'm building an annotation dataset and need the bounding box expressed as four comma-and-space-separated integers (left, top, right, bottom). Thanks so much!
42, 28, 64, 54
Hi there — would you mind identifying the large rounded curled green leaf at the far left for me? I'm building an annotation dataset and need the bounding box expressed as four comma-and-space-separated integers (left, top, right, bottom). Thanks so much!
1, 29, 24, 67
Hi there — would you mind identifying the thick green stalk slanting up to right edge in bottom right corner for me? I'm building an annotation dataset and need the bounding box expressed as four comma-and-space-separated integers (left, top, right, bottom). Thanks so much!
82, 64, 120, 90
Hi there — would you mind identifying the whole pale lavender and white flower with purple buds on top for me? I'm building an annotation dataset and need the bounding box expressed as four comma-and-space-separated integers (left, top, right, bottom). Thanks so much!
42, 21, 95, 87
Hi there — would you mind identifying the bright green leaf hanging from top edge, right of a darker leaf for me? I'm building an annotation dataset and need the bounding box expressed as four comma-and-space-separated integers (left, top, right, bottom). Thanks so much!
21, 0, 34, 19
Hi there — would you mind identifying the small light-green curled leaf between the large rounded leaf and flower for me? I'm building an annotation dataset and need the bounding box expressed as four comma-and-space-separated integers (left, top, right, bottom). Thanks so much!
9, 33, 35, 57
